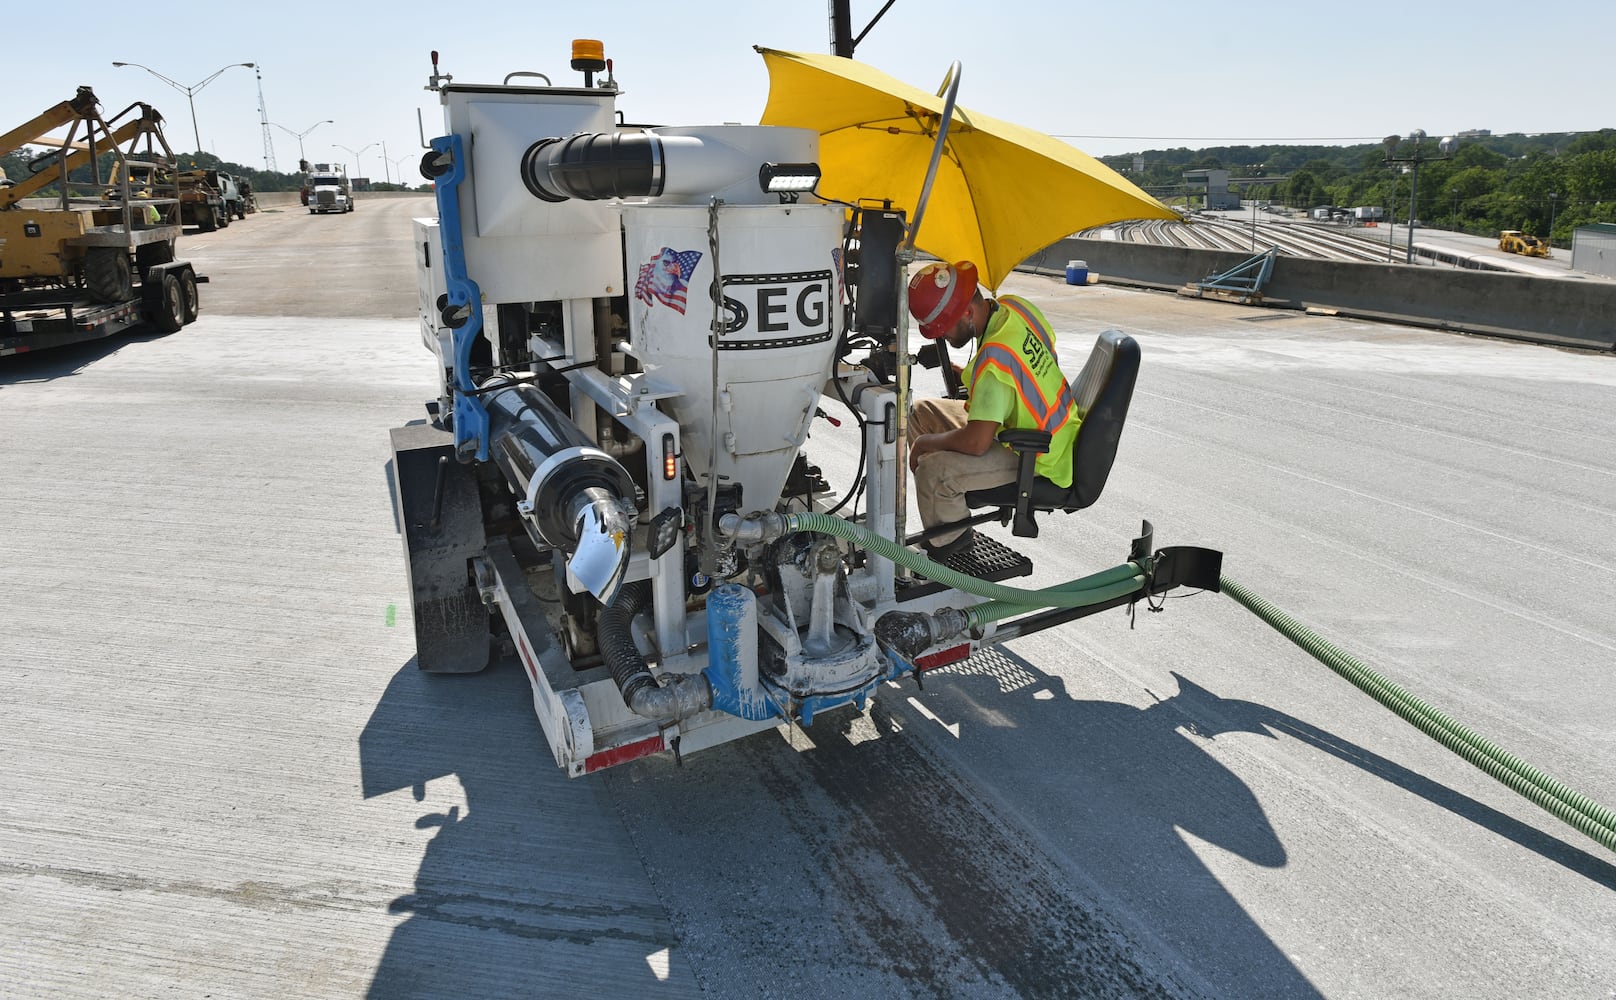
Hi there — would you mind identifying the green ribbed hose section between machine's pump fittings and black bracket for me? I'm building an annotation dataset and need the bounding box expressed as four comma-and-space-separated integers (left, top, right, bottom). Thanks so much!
784, 511, 1144, 613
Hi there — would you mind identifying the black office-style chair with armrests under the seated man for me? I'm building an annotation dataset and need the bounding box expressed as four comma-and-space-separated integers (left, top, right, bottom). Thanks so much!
965, 330, 1139, 538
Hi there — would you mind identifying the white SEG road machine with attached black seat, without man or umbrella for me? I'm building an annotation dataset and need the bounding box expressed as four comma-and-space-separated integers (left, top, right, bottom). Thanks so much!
391, 40, 1222, 775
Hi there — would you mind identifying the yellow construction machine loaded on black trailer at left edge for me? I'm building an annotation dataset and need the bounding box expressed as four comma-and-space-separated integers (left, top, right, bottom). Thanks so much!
0, 87, 207, 355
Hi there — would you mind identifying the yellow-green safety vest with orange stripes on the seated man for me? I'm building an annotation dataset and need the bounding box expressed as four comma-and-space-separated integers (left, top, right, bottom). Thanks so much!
963, 296, 1081, 488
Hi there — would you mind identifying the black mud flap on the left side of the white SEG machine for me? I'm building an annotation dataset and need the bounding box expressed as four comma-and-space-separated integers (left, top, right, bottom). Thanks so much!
391, 423, 493, 674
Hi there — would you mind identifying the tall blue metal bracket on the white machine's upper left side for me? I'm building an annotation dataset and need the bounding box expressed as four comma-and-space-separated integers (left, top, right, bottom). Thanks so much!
431, 136, 488, 462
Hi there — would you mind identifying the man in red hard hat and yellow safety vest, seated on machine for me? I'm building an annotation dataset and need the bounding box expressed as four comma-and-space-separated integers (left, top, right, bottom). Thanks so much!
908, 260, 1081, 561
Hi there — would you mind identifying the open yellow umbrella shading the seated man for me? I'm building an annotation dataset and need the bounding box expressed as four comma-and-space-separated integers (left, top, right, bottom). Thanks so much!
758, 47, 1178, 288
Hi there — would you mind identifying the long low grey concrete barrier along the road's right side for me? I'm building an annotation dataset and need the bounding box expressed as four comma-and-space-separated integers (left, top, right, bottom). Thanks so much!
1028, 237, 1616, 351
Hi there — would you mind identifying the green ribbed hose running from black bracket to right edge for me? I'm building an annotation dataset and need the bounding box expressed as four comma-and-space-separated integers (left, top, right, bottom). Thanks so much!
1222, 577, 1616, 851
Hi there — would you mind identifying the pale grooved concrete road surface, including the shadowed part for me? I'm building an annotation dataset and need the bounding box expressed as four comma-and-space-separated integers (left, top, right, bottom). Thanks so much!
0, 199, 1616, 1000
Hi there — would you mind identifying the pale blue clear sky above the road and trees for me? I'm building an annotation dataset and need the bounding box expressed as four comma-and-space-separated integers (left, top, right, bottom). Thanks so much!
12, 0, 1616, 183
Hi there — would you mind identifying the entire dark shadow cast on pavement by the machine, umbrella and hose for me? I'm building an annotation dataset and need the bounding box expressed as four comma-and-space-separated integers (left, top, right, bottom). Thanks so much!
347, 648, 1616, 997
